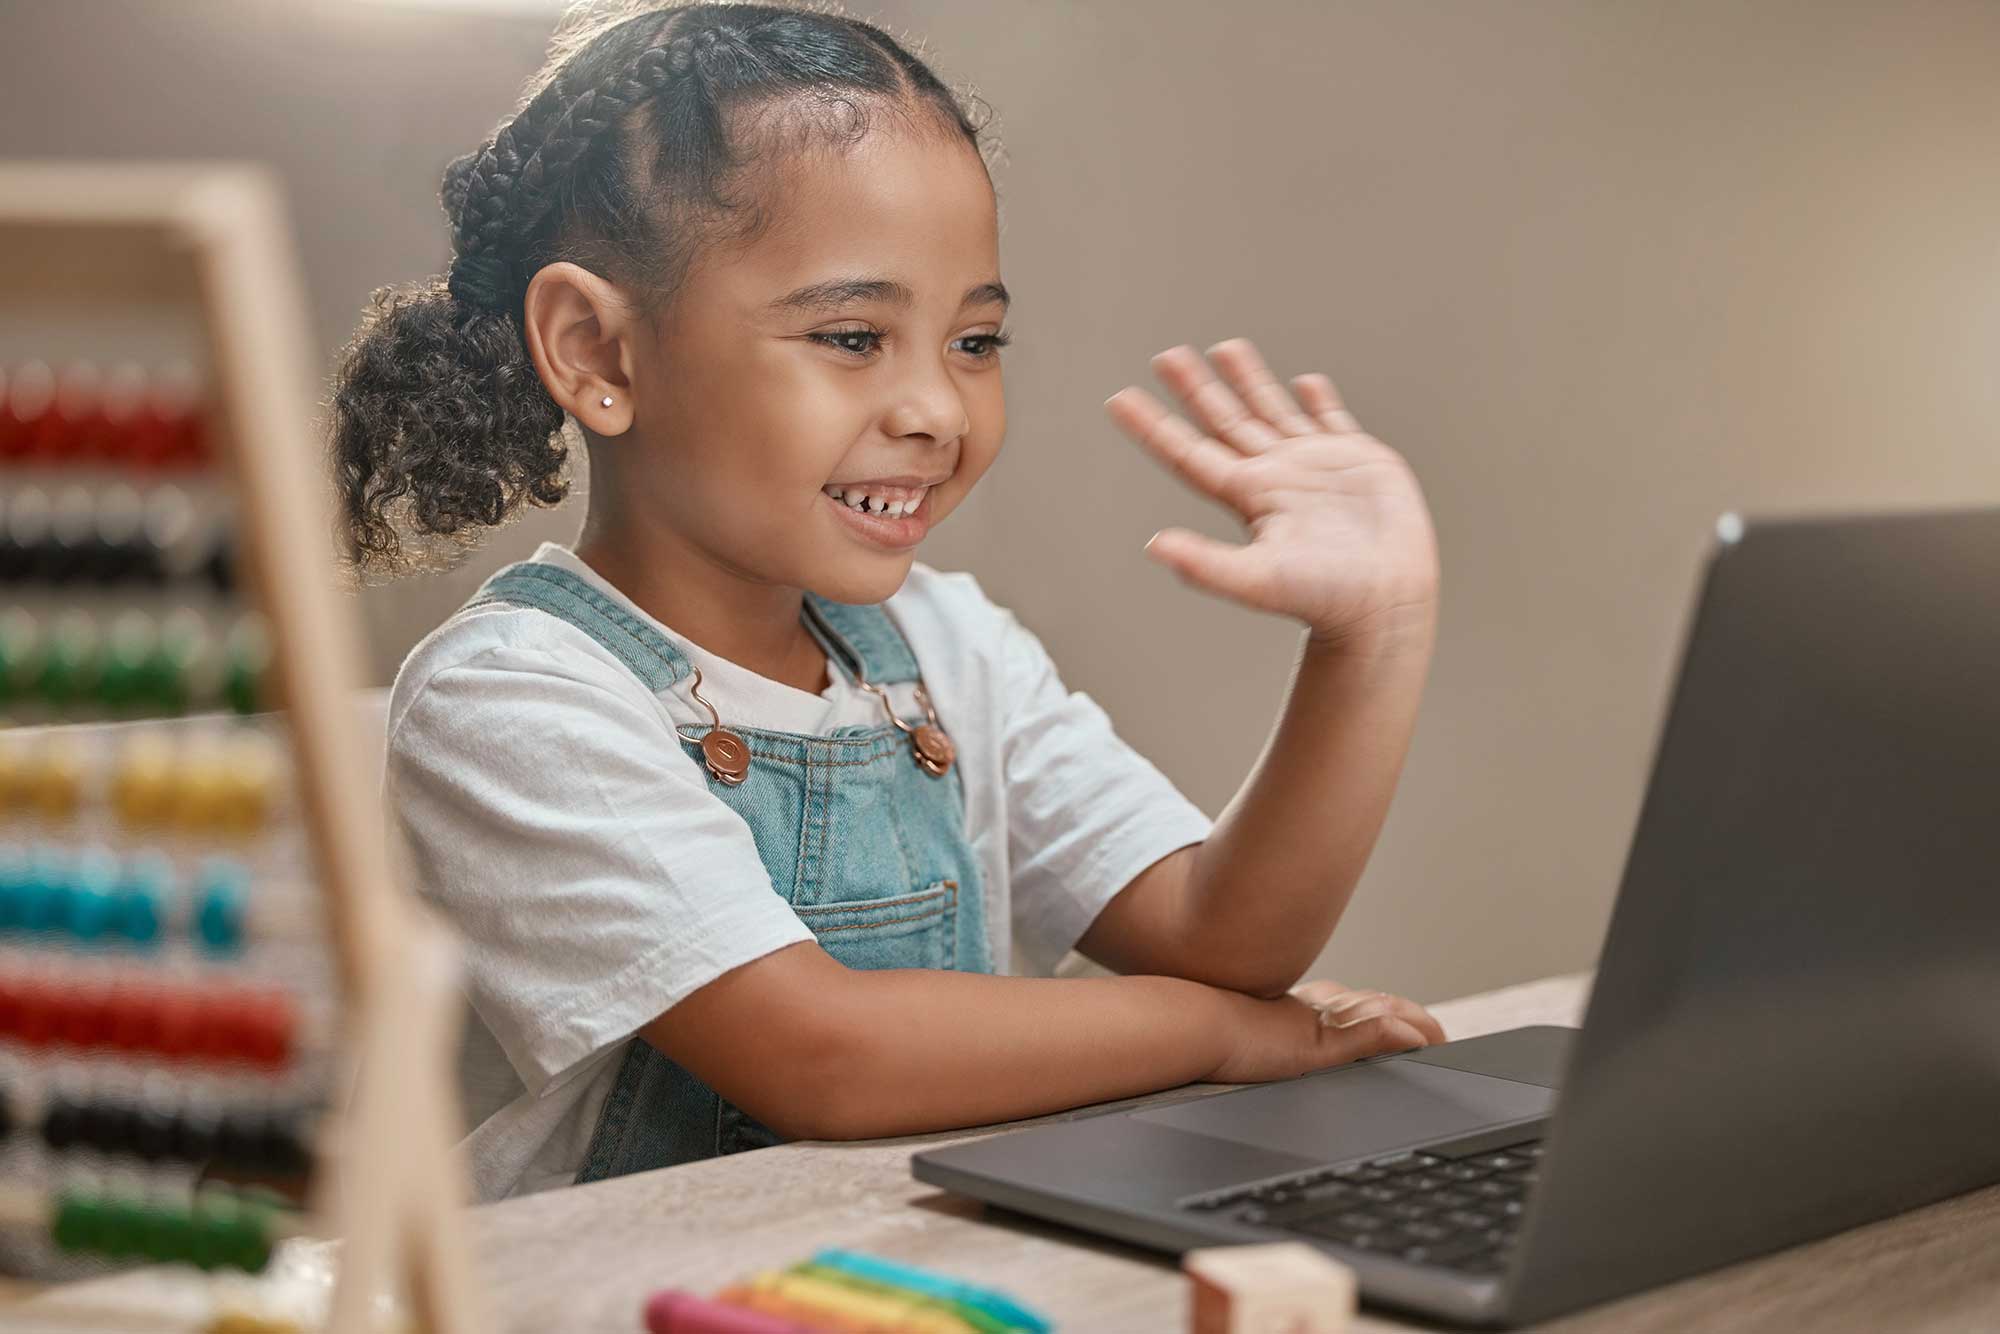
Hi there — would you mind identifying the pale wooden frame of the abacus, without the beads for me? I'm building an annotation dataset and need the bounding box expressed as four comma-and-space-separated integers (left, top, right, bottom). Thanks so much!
0, 164, 488, 1334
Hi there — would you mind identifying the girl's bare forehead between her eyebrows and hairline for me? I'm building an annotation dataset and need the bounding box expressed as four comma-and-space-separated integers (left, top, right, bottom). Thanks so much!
712, 130, 1000, 318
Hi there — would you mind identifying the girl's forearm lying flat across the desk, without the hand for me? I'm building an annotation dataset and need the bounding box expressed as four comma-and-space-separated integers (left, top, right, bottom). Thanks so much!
800, 968, 1242, 1140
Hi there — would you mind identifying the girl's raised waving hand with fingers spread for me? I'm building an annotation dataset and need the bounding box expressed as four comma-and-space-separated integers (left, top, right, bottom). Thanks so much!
1104, 338, 1438, 652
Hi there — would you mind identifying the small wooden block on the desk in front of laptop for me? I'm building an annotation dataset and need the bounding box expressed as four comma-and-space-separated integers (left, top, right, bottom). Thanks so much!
1180, 1242, 1354, 1334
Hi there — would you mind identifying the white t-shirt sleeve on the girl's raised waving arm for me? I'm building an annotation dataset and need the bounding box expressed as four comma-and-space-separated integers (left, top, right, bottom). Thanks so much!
996, 608, 1214, 972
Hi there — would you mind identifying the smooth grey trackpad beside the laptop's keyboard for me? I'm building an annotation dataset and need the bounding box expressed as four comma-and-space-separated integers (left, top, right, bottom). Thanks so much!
1132, 1060, 1556, 1162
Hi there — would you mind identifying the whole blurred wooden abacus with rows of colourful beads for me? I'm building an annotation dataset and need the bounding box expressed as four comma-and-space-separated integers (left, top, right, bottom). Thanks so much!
0, 164, 484, 1334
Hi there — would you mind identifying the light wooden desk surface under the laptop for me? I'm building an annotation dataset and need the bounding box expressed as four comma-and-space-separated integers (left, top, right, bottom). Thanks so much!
15, 976, 2000, 1334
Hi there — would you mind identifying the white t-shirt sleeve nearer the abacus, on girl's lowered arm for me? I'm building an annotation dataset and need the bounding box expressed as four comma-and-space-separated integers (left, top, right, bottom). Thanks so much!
384, 648, 812, 1094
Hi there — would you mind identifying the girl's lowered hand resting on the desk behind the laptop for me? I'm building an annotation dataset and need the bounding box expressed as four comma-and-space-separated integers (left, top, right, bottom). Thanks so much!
1208, 980, 1446, 1084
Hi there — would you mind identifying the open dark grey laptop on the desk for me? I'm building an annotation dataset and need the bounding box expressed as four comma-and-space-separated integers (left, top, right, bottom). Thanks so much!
912, 510, 2000, 1326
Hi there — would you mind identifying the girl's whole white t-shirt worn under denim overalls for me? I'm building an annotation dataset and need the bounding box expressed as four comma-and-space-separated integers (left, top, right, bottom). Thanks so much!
384, 542, 1210, 1200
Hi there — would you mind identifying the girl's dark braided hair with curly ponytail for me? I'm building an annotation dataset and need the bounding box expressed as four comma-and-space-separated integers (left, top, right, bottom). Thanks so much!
332, 0, 986, 572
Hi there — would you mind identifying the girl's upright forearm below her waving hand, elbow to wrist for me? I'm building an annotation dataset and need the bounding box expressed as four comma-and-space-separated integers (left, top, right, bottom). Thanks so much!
1182, 608, 1436, 996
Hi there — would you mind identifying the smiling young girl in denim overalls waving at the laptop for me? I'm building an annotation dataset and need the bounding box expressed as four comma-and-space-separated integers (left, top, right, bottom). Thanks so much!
334, 4, 1442, 1198
